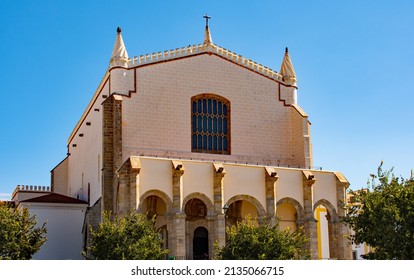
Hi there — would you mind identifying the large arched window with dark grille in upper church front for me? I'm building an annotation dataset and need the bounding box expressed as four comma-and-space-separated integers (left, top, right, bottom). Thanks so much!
191, 94, 230, 154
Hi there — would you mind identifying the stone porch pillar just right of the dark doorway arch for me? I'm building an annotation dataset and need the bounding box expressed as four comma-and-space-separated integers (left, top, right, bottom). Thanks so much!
213, 163, 226, 250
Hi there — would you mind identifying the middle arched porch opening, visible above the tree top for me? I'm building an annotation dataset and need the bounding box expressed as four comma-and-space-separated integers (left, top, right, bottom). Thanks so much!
226, 200, 259, 226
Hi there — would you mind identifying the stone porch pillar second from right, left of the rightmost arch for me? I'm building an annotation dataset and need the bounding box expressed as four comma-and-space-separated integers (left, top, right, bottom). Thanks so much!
302, 171, 318, 259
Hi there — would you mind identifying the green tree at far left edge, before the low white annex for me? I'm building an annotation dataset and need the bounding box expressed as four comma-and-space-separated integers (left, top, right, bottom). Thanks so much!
0, 203, 47, 260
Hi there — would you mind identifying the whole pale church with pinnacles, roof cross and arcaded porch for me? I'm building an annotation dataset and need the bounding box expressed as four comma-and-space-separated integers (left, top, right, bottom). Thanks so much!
51, 21, 351, 259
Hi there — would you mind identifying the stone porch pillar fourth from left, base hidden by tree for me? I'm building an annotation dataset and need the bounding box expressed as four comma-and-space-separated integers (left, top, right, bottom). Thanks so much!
265, 167, 279, 226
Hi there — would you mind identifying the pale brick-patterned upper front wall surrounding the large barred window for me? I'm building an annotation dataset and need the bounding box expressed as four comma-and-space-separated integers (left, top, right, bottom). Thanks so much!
123, 54, 304, 165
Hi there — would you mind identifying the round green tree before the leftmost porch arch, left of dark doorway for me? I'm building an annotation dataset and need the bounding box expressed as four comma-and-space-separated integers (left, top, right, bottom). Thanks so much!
88, 212, 168, 260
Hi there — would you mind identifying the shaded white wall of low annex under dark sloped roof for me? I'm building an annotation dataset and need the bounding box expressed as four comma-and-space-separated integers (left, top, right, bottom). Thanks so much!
22, 203, 86, 260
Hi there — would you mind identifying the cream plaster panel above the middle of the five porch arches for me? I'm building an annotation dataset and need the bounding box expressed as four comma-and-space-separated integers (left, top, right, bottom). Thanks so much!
224, 164, 266, 209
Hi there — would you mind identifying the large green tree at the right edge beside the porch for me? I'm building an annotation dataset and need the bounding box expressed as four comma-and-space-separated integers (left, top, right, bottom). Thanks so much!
344, 162, 414, 260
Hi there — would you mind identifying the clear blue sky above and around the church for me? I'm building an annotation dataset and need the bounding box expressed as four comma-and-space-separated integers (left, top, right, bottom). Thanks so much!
0, 0, 414, 199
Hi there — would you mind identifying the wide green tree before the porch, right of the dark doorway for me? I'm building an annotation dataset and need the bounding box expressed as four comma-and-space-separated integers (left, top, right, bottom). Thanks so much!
217, 217, 310, 260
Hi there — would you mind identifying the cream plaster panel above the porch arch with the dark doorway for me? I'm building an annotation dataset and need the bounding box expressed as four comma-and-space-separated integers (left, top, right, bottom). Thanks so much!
183, 161, 214, 207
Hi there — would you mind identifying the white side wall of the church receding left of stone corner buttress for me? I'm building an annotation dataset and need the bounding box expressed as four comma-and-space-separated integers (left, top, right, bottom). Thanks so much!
68, 83, 109, 205
